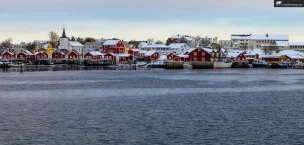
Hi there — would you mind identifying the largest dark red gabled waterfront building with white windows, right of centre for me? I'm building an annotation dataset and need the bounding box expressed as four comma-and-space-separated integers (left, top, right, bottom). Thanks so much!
186, 48, 214, 62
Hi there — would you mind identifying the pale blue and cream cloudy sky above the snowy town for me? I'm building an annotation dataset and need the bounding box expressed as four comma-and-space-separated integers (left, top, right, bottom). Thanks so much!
0, 0, 304, 42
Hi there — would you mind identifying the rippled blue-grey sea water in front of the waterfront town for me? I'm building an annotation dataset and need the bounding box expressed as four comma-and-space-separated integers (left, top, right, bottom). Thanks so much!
0, 69, 304, 145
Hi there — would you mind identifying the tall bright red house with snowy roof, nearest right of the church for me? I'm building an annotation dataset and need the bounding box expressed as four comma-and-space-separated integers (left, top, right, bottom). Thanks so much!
102, 40, 125, 54
